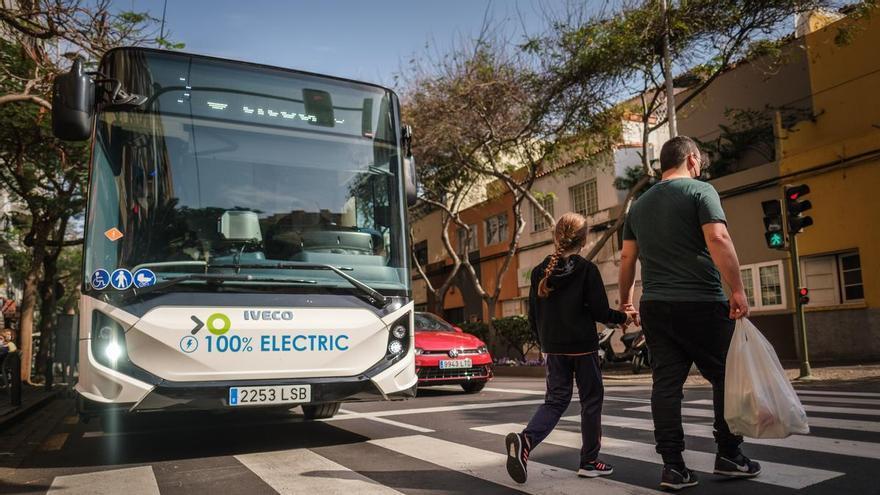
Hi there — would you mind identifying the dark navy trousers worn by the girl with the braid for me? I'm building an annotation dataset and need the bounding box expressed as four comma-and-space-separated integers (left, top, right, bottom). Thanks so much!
523, 352, 605, 465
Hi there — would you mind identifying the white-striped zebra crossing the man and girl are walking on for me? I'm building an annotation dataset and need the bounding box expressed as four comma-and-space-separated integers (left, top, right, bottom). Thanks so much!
25, 386, 880, 495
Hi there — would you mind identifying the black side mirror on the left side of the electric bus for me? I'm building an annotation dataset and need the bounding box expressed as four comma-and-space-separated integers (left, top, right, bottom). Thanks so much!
52, 60, 95, 141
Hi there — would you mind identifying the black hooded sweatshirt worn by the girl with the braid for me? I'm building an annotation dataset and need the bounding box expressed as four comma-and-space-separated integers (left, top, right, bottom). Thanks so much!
529, 255, 626, 354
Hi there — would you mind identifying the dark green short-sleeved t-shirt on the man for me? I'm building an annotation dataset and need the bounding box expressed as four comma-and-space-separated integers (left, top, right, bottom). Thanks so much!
623, 179, 727, 302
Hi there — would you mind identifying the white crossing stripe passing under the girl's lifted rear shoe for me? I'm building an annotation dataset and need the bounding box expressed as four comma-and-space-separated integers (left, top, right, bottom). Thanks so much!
369, 432, 659, 495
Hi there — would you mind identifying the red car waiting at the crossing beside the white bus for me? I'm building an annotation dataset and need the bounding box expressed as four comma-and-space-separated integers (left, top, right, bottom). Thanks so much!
415, 313, 492, 394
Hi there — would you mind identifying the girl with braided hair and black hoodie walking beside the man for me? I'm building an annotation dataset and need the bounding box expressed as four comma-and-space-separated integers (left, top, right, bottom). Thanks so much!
505, 213, 636, 483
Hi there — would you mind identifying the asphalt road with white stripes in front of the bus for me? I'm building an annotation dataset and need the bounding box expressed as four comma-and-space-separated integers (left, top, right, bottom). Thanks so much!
0, 378, 880, 495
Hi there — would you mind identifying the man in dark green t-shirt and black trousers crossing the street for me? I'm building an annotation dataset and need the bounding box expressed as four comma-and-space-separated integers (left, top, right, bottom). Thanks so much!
619, 136, 761, 489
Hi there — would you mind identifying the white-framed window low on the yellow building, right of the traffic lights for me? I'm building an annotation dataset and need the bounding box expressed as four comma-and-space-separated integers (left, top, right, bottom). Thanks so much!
801, 252, 865, 306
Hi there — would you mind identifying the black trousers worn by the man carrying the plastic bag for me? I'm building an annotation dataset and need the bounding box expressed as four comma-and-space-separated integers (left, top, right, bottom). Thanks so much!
639, 301, 742, 466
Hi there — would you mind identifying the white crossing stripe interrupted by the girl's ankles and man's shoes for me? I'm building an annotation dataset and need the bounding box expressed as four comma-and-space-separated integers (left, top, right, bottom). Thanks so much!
471, 424, 844, 490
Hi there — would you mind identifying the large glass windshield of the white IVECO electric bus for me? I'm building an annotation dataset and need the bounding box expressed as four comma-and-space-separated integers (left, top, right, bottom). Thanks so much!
84, 49, 409, 293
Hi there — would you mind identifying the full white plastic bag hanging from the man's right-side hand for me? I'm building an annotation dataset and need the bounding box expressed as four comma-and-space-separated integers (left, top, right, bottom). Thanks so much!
724, 318, 810, 438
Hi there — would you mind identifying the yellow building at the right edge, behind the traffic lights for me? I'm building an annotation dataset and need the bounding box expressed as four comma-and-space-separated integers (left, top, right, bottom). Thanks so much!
777, 10, 880, 361
